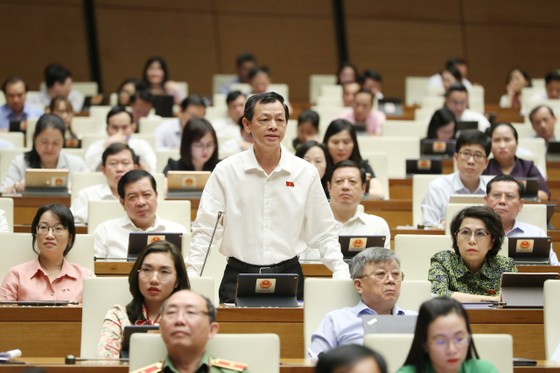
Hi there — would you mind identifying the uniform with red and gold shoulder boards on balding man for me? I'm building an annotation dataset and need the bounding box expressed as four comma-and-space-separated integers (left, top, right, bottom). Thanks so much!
132, 352, 249, 373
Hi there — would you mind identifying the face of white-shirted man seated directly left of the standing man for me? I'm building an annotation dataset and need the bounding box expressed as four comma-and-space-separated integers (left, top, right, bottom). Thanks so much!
120, 177, 157, 230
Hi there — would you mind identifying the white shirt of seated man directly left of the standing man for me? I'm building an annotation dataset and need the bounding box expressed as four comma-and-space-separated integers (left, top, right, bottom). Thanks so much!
93, 216, 187, 259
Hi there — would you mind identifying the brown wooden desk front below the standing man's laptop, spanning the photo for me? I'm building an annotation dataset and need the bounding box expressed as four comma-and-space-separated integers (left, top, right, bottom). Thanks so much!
0, 306, 545, 360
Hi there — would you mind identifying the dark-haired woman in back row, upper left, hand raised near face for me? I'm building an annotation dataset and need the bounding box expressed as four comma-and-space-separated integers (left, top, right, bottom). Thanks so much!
142, 56, 185, 104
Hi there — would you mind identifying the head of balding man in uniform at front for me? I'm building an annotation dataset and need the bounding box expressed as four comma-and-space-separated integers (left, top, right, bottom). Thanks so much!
159, 290, 219, 352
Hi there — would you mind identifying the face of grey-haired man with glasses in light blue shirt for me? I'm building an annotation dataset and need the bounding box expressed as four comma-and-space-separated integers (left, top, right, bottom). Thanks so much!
354, 260, 402, 312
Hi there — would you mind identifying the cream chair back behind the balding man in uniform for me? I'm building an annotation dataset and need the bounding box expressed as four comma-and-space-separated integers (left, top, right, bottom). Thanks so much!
129, 333, 280, 373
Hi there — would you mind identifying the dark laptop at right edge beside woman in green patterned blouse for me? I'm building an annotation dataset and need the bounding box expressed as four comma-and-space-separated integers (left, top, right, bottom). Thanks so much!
501, 272, 560, 308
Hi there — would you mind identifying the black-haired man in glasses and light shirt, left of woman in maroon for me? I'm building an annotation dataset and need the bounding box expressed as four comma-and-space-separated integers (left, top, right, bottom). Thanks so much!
421, 130, 491, 226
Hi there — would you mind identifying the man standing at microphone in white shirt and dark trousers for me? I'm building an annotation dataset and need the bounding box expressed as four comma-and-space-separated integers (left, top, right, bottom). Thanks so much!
187, 92, 350, 303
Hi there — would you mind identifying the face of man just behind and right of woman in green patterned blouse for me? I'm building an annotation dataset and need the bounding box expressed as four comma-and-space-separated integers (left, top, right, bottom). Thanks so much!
484, 181, 523, 226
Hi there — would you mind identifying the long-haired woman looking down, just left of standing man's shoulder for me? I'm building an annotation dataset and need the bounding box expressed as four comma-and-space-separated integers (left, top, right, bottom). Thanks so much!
163, 118, 219, 175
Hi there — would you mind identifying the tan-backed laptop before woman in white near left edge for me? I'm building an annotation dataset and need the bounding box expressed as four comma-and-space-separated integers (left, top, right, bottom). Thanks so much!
23, 168, 69, 196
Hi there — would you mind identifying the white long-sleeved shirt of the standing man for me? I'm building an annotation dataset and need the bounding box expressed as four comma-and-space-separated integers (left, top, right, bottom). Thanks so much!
187, 146, 350, 278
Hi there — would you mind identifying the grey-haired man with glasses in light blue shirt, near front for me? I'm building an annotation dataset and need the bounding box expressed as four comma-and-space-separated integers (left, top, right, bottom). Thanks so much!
307, 247, 416, 359
